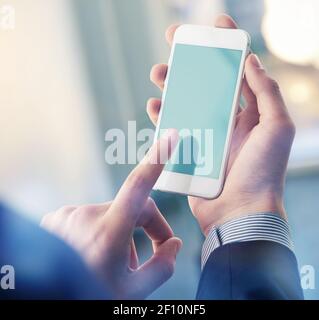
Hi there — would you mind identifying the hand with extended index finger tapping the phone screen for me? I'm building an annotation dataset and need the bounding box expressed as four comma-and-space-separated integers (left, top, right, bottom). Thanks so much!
42, 130, 182, 299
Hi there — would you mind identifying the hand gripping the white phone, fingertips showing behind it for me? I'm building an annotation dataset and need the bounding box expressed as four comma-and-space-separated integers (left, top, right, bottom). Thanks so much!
147, 15, 295, 234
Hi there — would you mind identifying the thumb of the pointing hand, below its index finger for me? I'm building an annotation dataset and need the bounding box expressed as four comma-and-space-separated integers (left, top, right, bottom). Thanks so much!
134, 237, 182, 298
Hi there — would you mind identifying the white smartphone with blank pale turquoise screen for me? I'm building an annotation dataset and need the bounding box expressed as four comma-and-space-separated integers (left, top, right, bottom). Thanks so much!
154, 25, 250, 199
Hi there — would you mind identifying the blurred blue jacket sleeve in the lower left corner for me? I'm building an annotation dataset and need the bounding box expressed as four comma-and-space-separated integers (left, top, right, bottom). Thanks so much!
0, 203, 109, 300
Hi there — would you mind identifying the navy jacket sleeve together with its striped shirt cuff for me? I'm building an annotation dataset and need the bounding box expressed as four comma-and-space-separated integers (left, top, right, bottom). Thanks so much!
196, 213, 303, 300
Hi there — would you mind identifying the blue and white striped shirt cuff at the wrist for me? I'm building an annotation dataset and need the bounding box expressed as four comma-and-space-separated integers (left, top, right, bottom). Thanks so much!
201, 213, 293, 269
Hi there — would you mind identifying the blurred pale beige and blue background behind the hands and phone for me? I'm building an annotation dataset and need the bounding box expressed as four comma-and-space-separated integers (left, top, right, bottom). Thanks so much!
0, 0, 319, 299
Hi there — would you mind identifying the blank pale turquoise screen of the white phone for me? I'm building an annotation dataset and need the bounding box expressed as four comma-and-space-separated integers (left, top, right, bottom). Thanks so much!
159, 44, 243, 179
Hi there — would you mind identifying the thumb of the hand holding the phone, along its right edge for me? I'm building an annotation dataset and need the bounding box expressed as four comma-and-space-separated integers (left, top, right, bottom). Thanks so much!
245, 54, 289, 121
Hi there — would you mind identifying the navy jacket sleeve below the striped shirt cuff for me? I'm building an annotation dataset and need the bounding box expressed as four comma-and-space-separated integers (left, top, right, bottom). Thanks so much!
197, 241, 303, 300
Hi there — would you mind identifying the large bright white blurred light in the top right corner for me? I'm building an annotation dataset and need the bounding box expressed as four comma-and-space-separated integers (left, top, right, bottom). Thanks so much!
262, 0, 319, 67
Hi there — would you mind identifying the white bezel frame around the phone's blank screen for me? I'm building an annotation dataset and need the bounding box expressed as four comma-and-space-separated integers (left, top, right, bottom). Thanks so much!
153, 25, 250, 199
